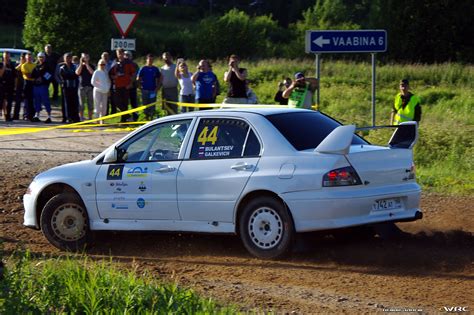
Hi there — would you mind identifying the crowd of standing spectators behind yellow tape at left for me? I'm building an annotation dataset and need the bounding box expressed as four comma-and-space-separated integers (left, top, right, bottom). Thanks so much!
0, 44, 266, 123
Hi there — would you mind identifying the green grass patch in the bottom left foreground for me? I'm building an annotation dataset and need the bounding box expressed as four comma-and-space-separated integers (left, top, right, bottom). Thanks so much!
0, 252, 235, 314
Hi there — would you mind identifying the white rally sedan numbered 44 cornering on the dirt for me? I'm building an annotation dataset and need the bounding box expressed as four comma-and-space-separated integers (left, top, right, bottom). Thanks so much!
23, 108, 422, 258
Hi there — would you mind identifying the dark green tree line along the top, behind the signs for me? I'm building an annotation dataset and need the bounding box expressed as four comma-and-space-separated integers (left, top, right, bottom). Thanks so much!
7, 0, 474, 63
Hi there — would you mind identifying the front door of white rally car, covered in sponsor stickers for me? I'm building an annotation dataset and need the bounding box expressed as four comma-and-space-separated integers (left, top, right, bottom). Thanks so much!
96, 119, 192, 220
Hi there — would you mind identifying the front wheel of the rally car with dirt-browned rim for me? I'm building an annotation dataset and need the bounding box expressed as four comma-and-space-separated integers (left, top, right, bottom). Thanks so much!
40, 193, 90, 251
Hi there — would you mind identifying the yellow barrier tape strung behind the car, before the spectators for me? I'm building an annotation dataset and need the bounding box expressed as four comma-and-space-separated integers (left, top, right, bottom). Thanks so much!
0, 100, 318, 136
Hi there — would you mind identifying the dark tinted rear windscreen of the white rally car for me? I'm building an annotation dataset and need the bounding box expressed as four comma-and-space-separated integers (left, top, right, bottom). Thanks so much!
266, 112, 367, 151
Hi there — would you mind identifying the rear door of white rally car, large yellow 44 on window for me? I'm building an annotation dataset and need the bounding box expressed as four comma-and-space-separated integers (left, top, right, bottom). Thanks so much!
177, 118, 261, 222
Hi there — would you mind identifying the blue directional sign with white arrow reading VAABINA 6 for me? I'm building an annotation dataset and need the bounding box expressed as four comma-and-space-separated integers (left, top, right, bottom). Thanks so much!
306, 30, 387, 54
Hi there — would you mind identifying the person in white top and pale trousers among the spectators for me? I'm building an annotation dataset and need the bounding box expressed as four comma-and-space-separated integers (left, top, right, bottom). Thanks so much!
91, 59, 110, 124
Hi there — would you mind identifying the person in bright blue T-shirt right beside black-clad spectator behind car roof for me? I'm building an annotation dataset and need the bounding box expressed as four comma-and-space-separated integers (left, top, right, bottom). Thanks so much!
192, 59, 217, 104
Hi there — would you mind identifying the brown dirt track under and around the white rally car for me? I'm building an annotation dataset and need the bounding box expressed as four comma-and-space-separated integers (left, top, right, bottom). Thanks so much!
0, 122, 474, 314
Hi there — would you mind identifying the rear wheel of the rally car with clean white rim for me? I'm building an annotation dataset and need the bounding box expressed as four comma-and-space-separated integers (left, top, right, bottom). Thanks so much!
239, 197, 295, 259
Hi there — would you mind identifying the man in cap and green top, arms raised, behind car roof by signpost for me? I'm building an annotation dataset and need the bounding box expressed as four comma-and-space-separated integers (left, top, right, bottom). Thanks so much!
282, 72, 319, 109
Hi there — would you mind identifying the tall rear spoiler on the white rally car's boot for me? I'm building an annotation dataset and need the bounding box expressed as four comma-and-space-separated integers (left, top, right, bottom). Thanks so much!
314, 121, 418, 154
